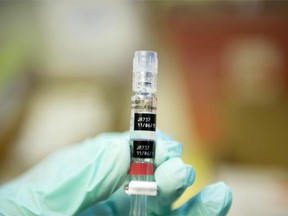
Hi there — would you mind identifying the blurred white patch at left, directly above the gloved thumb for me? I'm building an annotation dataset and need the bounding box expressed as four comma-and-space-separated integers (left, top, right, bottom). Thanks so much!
0, 83, 113, 180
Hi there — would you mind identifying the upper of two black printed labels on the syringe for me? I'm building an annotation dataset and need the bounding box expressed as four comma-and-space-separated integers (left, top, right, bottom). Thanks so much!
134, 113, 156, 131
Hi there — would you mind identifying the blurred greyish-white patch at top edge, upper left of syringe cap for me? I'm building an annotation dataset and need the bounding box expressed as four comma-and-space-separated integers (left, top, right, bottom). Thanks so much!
39, 1, 148, 79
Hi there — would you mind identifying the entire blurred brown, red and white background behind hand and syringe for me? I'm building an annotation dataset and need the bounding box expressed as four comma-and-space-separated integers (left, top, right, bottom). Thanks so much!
0, 0, 288, 215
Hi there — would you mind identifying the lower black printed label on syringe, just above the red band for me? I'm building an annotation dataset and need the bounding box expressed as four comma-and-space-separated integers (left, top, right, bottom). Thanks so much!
132, 140, 154, 158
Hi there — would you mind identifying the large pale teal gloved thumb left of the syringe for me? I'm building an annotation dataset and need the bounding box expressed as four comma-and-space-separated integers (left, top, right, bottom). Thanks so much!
0, 133, 130, 215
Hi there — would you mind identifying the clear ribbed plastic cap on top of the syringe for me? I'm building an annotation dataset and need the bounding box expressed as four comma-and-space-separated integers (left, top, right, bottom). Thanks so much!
133, 51, 158, 93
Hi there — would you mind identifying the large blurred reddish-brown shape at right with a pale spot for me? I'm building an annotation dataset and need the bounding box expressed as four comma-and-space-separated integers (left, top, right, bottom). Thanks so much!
159, 1, 288, 168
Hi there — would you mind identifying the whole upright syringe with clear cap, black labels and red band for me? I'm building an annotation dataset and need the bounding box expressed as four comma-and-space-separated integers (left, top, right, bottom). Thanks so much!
125, 51, 158, 216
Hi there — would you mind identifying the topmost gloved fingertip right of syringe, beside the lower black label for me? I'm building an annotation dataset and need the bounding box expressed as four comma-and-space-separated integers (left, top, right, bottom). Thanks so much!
155, 129, 182, 167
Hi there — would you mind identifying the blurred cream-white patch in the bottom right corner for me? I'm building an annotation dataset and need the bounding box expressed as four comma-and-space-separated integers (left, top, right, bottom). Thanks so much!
217, 165, 288, 216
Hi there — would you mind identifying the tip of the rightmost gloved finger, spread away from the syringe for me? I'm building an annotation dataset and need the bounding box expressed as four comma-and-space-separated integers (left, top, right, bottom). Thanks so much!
201, 181, 232, 215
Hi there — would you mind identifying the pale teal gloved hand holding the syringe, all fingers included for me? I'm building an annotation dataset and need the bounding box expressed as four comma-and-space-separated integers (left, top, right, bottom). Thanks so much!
0, 132, 232, 216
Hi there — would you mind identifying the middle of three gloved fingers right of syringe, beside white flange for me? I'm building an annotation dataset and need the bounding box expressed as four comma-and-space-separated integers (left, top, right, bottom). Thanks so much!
148, 157, 195, 214
